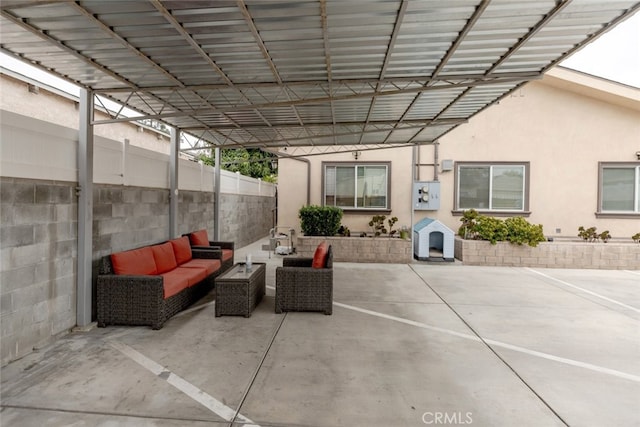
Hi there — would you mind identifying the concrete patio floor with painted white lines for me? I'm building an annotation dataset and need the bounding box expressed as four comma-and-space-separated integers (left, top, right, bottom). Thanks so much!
0, 242, 640, 427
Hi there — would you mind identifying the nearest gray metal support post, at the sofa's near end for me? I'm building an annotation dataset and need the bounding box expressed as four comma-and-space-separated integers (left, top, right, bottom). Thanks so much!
76, 89, 93, 326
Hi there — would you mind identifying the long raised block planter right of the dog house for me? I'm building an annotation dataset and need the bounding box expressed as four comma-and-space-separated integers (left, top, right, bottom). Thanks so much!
455, 238, 640, 270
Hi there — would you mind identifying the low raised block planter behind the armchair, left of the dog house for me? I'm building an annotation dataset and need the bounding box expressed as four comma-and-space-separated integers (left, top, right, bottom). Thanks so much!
296, 236, 411, 264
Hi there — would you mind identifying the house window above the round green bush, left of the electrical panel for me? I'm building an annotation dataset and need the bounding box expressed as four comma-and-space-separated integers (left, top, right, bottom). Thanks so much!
322, 163, 391, 210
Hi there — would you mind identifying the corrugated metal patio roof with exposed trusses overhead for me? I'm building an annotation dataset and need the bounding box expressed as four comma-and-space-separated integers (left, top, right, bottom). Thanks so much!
0, 0, 640, 147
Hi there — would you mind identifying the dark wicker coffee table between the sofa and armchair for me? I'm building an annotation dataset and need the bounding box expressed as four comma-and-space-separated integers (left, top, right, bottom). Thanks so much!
215, 263, 266, 317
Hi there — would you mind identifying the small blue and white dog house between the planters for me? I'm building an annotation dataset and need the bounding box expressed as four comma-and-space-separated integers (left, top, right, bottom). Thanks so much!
413, 218, 455, 261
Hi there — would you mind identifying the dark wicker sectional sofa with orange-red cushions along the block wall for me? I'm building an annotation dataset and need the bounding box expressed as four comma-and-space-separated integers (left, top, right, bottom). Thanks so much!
97, 237, 228, 329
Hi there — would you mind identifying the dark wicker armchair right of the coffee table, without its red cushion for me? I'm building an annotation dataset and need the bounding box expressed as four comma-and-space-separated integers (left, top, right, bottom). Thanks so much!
275, 246, 333, 315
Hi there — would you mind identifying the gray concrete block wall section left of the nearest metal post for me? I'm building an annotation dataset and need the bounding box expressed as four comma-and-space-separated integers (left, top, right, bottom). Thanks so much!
0, 178, 78, 365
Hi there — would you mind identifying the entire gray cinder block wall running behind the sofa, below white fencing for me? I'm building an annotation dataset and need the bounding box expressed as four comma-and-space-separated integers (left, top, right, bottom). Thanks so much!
0, 177, 275, 366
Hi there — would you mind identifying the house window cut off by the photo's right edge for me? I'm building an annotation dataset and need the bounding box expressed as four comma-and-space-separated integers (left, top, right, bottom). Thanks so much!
599, 163, 640, 213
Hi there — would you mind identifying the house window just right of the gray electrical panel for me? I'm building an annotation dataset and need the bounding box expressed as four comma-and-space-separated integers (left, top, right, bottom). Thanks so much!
456, 163, 529, 212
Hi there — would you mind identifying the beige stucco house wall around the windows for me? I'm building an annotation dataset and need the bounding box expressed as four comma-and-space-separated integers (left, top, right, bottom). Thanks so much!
278, 68, 640, 241
